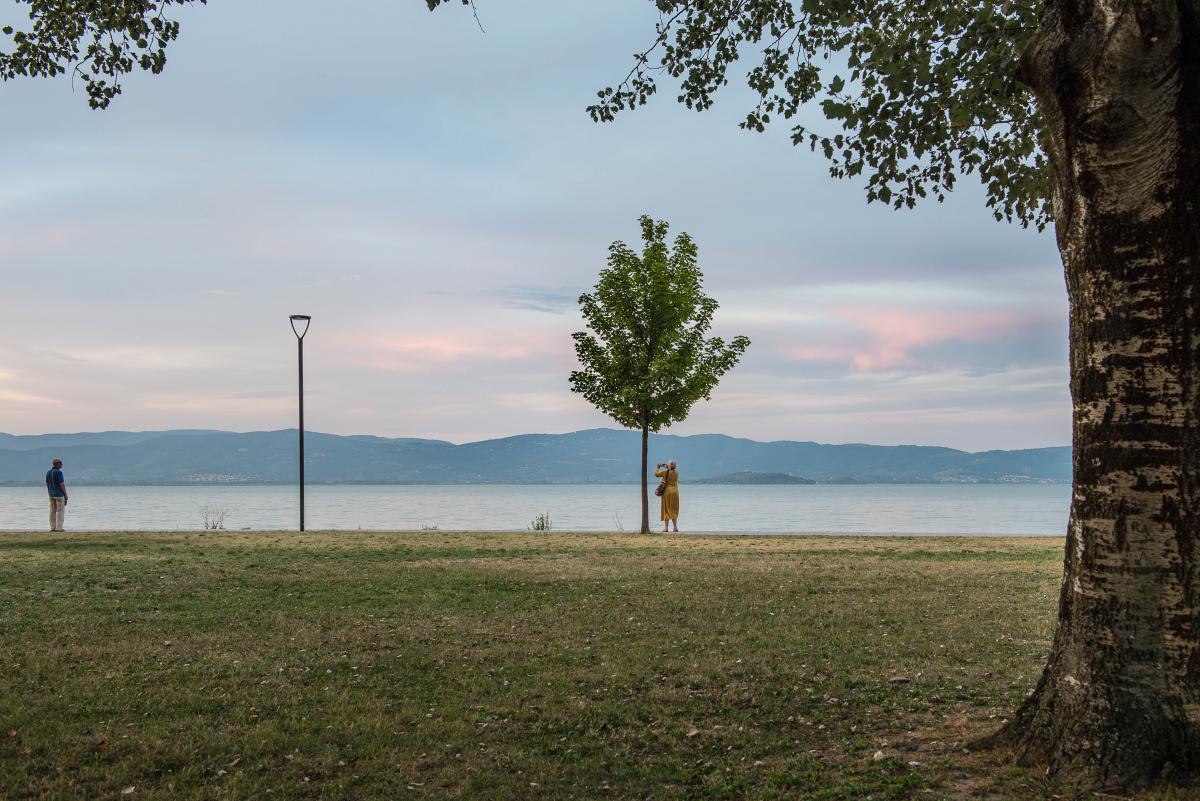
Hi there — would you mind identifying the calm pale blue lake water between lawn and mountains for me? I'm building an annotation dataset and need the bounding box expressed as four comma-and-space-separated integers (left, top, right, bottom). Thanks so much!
0, 476, 1070, 535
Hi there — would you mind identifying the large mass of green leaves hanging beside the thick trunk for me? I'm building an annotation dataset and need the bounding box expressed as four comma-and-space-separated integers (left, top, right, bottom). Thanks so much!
588, 0, 1051, 229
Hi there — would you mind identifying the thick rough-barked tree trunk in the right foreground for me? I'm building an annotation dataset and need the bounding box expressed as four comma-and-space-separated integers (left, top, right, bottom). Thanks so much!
998, 0, 1200, 788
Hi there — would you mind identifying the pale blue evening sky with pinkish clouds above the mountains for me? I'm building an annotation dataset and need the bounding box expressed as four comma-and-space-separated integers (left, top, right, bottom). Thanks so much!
0, 0, 1070, 451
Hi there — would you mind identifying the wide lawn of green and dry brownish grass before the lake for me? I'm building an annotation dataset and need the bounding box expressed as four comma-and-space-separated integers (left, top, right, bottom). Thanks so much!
0, 531, 1193, 801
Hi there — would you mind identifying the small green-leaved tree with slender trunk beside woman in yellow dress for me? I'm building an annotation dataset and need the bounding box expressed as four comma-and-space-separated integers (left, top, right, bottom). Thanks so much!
570, 216, 750, 534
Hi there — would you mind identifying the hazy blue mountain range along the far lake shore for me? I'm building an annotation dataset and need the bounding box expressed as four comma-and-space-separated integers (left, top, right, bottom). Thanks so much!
0, 428, 1070, 486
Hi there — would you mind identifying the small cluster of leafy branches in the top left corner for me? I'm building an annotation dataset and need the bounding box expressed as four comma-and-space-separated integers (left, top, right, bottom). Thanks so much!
0, 0, 208, 109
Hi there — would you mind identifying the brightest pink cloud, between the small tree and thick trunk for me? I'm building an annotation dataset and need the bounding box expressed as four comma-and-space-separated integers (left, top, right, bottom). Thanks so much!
786, 307, 1036, 372
